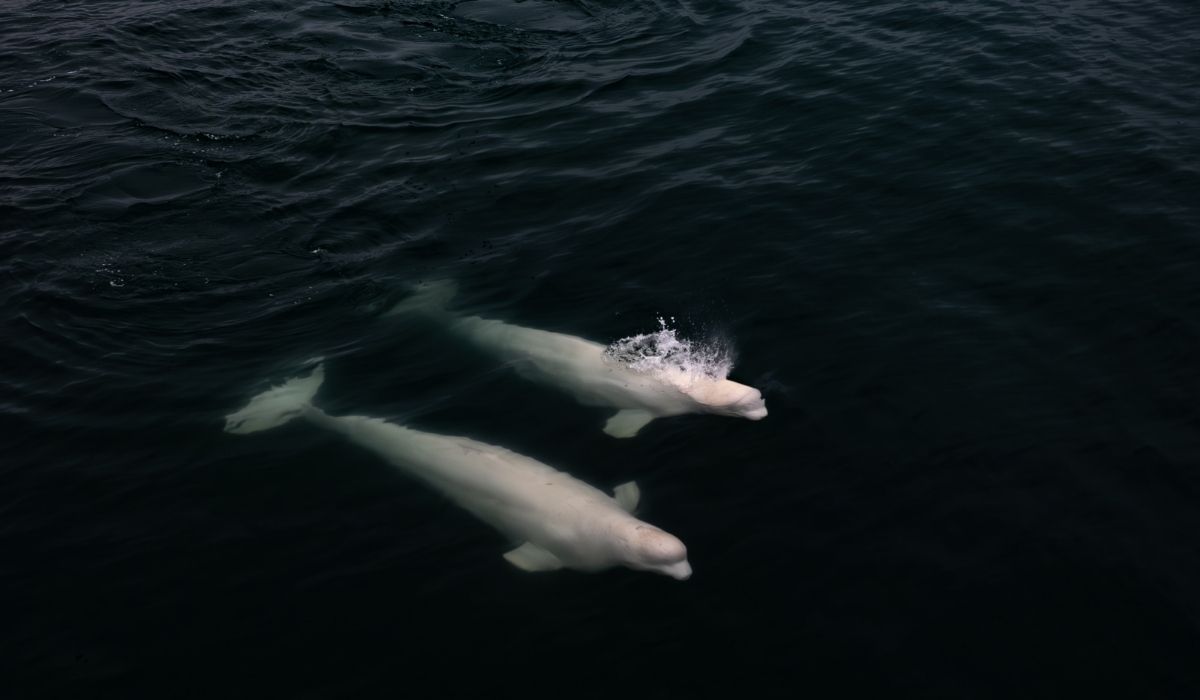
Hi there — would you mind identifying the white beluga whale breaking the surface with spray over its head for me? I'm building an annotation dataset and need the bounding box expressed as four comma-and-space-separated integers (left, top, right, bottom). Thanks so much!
386, 281, 767, 437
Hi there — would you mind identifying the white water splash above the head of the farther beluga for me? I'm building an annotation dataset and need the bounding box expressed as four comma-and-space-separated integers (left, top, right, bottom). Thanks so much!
604, 316, 733, 379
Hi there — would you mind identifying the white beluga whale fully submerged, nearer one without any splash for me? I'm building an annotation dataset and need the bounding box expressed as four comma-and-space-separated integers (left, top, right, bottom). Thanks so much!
224, 365, 691, 580
